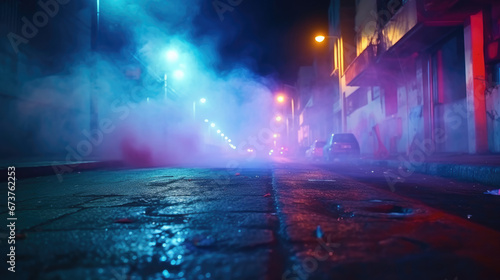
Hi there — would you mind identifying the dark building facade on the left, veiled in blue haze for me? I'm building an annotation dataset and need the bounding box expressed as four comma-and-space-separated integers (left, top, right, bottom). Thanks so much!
0, 0, 90, 158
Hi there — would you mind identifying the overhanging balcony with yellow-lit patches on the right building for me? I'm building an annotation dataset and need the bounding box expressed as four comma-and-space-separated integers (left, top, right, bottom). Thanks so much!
345, 0, 494, 86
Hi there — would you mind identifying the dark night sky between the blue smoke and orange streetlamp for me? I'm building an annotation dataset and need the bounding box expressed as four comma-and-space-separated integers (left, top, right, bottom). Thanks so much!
195, 0, 330, 83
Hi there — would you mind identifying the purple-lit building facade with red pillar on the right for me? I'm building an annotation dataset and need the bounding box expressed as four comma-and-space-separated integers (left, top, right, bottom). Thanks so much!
329, 0, 500, 157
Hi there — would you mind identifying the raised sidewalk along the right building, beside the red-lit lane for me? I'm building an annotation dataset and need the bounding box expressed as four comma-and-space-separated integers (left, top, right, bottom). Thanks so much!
356, 154, 500, 186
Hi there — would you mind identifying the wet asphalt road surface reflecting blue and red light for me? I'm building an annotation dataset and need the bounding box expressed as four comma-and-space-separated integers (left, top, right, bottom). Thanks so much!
0, 160, 500, 280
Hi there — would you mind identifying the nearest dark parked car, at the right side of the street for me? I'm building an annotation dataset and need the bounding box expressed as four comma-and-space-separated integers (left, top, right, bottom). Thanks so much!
323, 133, 359, 161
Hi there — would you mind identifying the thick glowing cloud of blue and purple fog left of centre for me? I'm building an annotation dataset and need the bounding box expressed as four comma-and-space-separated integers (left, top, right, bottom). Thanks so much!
4, 0, 284, 167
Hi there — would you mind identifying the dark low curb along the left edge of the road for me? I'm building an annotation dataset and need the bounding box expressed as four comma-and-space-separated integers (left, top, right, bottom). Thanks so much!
0, 161, 124, 181
